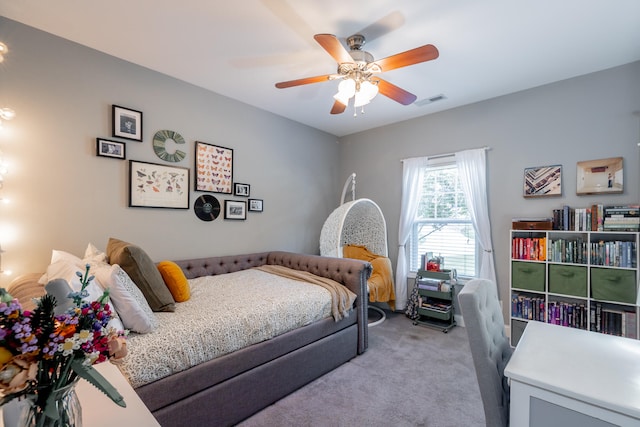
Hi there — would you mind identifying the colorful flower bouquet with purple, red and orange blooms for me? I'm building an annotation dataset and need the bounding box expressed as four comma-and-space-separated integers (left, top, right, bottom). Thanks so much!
0, 265, 126, 426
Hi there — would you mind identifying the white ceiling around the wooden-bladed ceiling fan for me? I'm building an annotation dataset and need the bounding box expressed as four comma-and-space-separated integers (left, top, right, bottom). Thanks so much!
0, 0, 640, 136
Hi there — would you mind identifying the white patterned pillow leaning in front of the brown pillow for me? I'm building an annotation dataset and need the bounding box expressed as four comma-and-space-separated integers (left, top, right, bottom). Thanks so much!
93, 264, 158, 334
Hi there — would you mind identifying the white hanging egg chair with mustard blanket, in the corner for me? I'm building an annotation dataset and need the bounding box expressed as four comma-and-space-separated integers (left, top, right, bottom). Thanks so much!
320, 174, 395, 326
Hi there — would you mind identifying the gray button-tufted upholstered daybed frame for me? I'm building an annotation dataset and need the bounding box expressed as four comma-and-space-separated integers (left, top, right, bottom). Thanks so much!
136, 252, 371, 426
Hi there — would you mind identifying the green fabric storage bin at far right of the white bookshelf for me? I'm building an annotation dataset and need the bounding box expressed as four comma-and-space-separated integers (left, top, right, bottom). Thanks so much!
591, 268, 637, 304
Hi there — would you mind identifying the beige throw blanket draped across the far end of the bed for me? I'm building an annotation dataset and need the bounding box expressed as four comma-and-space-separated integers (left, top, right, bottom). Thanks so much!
255, 265, 356, 322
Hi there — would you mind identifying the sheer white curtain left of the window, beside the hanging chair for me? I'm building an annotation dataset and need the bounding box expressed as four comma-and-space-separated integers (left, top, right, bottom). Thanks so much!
395, 157, 428, 310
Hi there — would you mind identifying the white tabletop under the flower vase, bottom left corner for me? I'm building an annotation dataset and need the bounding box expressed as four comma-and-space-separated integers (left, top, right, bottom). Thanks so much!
0, 362, 160, 427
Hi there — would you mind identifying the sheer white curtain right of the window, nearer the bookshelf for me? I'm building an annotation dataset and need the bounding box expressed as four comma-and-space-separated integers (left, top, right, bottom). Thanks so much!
455, 148, 497, 286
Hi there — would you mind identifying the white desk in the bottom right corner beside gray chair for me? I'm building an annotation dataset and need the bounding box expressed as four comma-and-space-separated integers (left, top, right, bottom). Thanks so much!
504, 322, 640, 427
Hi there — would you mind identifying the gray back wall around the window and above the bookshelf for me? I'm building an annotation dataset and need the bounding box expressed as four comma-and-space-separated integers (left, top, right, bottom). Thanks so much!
341, 62, 640, 315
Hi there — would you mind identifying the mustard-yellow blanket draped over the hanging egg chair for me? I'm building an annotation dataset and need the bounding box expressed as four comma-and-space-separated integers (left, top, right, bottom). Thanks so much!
342, 245, 396, 310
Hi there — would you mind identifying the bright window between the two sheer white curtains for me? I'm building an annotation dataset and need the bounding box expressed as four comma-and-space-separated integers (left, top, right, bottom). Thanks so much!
410, 163, 478, 277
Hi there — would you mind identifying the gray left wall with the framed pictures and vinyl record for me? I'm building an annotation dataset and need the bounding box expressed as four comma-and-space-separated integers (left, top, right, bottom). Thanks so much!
0, 17, 342, 280
